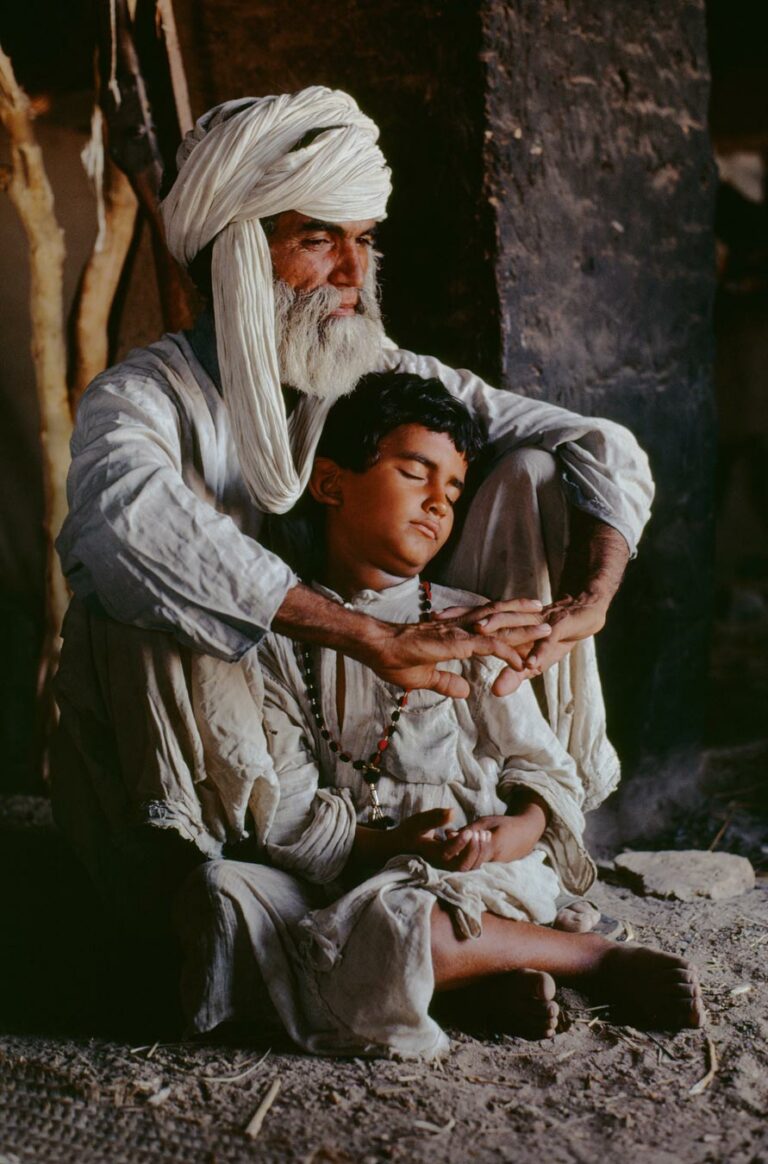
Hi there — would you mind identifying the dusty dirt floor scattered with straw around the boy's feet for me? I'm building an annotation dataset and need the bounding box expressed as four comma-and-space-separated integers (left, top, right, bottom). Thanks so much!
0, 878, 768, 1164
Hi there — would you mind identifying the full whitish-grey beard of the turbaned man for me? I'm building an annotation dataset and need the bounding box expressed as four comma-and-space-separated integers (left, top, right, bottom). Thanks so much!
275, 261, 385, 400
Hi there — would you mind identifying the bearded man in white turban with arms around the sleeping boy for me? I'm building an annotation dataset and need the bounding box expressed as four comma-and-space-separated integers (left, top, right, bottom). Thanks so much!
54, 88, 652, 945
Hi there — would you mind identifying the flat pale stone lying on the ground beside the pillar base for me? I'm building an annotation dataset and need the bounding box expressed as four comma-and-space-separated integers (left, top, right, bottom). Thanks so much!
613, 849, 755, 901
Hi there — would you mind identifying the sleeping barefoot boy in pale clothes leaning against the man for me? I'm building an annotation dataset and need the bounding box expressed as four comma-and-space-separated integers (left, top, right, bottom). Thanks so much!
180, 372, 703, 1056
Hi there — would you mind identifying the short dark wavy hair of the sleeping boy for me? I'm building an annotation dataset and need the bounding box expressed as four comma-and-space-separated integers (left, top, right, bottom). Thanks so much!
317, 371, 485, 473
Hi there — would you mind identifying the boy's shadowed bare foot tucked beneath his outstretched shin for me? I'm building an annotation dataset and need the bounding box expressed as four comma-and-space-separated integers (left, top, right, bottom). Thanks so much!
441, 970, 560, 1039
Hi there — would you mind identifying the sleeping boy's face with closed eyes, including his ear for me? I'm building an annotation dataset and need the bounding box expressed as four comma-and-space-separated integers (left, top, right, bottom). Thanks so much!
318, 425, 467, 577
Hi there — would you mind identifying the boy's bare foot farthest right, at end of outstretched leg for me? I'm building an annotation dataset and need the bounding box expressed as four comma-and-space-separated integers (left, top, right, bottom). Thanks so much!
588, 944, 705, 1030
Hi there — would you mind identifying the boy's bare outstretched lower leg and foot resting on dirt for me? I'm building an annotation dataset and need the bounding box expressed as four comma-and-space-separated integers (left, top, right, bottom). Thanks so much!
432, 904, 704, 1029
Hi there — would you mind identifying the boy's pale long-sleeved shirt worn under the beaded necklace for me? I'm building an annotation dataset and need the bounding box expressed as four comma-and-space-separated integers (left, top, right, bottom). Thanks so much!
259, 579, 595, 893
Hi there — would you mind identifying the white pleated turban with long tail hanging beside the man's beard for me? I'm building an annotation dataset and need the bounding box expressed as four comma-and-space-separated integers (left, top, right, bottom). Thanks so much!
162, 86, 391, 513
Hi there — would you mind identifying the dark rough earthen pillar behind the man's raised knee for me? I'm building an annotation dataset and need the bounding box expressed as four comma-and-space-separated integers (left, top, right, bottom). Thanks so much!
482, 0, 716, 765
